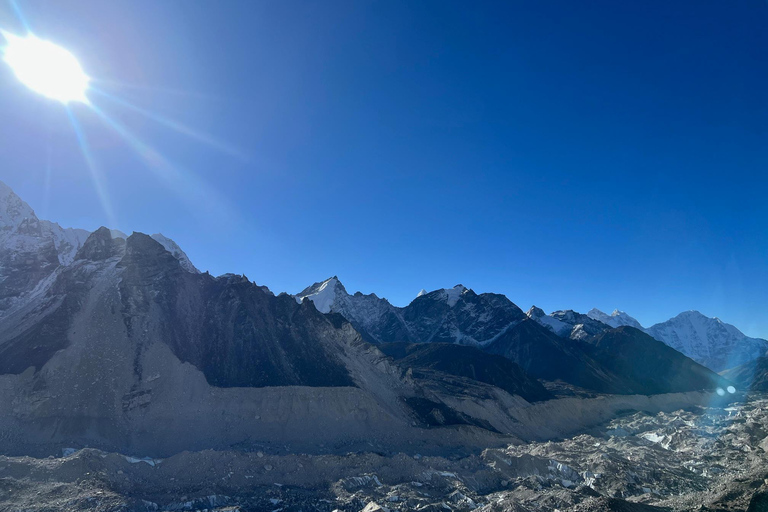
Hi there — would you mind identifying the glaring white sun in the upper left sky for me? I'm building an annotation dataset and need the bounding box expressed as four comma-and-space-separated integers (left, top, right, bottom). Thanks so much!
0, 31, 90, 104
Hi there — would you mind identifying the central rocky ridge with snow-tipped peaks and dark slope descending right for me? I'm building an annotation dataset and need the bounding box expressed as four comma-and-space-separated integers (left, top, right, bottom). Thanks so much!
295, 276, 728, 393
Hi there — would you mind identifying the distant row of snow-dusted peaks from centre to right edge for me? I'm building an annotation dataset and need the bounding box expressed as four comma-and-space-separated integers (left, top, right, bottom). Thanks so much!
296, 276, 768, 372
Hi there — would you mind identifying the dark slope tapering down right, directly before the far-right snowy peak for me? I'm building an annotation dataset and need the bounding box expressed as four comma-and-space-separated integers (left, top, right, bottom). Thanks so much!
589, 326, 730, 394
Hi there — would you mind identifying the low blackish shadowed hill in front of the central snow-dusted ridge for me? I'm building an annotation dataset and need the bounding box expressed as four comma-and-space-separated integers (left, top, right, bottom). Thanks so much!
379, 343, 552, 402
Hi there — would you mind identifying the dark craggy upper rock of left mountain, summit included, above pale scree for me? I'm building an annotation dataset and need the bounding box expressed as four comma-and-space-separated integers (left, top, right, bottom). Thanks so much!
0, 228, 354, 387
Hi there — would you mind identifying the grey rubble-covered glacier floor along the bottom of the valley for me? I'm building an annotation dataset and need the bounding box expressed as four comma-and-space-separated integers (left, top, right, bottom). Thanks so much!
0, 396, 768, 512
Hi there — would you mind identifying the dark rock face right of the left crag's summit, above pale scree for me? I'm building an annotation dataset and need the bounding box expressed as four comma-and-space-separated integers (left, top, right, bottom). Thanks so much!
166, 281, 354, 387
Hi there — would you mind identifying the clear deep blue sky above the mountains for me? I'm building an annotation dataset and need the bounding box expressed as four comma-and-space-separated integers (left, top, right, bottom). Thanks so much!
0, 0, 768, 337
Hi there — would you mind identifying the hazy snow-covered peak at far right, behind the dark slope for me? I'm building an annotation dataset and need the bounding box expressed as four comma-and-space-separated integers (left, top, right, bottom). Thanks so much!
647, 311, 768, 372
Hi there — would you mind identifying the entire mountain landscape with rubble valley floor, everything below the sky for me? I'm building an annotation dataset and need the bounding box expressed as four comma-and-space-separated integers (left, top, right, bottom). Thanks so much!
0, 183, 768, 512
